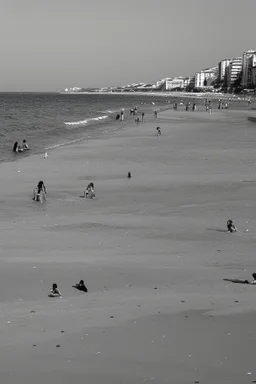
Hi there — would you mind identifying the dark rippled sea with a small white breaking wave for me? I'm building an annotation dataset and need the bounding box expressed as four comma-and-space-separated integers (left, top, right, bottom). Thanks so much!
0, 93, 170, 161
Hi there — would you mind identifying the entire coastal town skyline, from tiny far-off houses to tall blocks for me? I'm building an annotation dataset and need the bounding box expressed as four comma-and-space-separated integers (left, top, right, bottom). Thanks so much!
63, 50, 256, 94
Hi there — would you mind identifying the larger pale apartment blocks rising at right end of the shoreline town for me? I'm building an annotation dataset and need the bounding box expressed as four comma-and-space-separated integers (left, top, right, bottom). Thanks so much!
153, 50, 256, 91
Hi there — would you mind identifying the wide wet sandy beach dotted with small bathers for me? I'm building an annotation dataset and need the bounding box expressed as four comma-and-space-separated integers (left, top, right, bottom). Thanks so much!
0, 103, 256, 384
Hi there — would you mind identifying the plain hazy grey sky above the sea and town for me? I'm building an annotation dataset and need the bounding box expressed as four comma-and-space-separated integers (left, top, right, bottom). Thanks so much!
0, 0, 256, 91
